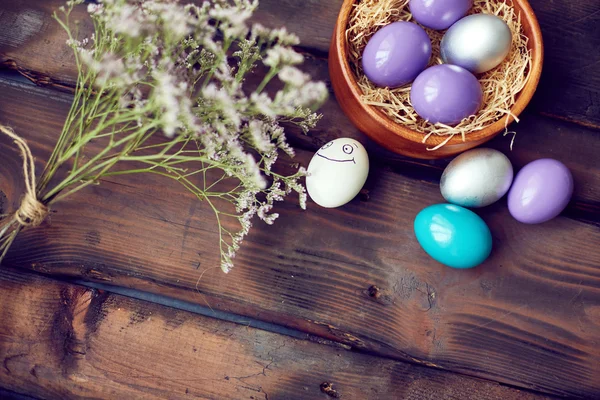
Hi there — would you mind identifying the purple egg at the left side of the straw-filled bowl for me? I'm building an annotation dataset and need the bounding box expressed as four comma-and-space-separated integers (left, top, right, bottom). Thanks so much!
362, 21, 431, 88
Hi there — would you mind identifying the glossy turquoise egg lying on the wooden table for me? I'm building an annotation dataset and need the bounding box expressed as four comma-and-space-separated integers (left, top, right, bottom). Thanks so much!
415, 204, 492, 268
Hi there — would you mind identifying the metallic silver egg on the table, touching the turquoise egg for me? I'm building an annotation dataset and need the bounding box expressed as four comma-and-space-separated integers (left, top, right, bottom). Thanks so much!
440, 149, 513, 208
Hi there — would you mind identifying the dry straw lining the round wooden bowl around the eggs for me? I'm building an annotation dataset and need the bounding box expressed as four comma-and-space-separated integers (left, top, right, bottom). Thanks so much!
346, 0, 532, 150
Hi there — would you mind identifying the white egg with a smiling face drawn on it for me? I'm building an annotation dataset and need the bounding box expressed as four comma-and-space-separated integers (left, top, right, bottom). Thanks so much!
306, 138, 369, 208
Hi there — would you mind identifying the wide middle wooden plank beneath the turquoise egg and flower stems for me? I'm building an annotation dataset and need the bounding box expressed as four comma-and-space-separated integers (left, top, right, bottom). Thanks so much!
0, 72, 600, 397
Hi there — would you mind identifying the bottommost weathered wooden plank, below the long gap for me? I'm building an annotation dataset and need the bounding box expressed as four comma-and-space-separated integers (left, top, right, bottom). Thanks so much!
0, 268, 543, 400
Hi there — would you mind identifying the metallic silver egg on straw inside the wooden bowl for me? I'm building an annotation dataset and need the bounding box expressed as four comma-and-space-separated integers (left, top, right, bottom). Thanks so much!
441, 14, 512, 74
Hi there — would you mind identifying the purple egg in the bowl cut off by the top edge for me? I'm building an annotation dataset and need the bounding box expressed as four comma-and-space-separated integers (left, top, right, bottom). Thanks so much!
408, 0, 473, 30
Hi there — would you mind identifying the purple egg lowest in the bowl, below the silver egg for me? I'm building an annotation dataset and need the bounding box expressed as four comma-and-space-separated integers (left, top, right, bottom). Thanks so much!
410, 64, 483, 125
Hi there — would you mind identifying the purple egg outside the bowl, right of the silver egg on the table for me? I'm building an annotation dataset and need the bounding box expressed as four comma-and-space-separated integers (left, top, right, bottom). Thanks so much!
508, 158, 573, 224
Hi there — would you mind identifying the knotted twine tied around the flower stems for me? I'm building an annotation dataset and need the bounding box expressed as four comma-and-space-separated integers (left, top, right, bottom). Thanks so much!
0, 125, 49, 227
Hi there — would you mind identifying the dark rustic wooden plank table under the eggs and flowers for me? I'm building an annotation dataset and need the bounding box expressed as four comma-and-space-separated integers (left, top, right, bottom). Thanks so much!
0, 0, 600, 400
